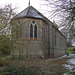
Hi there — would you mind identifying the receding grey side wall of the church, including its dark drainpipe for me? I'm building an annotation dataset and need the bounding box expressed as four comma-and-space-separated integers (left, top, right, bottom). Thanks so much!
49, 23, 66, 57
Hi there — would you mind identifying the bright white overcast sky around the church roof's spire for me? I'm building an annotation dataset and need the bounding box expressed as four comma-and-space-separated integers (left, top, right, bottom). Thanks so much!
0, 0, 41, 12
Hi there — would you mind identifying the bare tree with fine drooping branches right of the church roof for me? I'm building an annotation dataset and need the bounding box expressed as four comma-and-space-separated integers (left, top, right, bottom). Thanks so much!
43, 0, 75, 43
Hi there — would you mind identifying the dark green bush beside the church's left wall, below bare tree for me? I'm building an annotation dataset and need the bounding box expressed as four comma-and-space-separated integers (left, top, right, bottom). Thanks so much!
0, 35, 12, 55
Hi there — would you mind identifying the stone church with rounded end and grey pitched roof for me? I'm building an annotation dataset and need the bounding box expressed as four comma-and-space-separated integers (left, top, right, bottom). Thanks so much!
11, 6, 66, 57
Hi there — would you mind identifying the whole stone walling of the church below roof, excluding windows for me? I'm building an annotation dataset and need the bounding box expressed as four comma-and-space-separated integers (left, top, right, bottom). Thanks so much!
11, 18, 66, 57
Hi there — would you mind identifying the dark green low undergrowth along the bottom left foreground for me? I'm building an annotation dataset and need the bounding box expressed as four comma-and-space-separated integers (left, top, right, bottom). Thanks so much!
0, 66, 49, 75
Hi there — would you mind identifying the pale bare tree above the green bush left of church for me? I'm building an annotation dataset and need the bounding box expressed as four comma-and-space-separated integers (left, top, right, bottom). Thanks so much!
0, 4, 16, 35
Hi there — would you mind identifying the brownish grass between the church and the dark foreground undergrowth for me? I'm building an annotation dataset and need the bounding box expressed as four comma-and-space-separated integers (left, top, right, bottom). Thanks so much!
0, 56, 69, 75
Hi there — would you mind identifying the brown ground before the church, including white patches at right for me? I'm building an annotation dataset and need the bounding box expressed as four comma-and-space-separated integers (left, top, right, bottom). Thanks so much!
0, 54, 75, 75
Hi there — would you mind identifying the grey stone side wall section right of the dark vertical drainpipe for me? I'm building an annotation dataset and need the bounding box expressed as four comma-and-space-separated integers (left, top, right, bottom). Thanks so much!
53, 26, 66, 57
